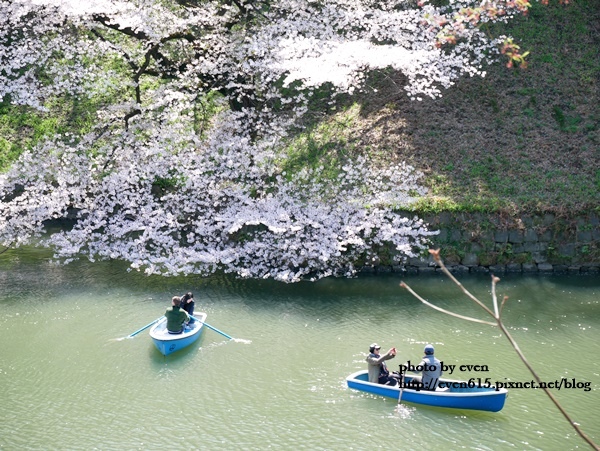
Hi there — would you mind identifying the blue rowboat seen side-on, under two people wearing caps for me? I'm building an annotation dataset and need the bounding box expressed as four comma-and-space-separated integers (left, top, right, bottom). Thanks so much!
346, 370, 508, 412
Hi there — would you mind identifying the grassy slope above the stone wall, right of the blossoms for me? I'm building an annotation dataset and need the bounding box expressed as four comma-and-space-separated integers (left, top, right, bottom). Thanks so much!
345, 0, 600, 213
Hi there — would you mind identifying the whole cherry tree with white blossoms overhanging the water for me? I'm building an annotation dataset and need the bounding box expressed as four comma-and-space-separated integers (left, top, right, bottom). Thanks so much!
0, 0, 540, 281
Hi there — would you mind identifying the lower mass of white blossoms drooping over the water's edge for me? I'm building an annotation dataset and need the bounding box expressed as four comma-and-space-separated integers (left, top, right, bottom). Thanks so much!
0, 107, 431, 281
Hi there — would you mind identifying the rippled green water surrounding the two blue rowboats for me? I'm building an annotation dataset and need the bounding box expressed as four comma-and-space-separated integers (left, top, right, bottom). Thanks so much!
0, 249, 600, 450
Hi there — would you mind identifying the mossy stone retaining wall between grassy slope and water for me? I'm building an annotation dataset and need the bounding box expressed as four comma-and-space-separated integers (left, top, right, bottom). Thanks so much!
364, 212, 600, 274
